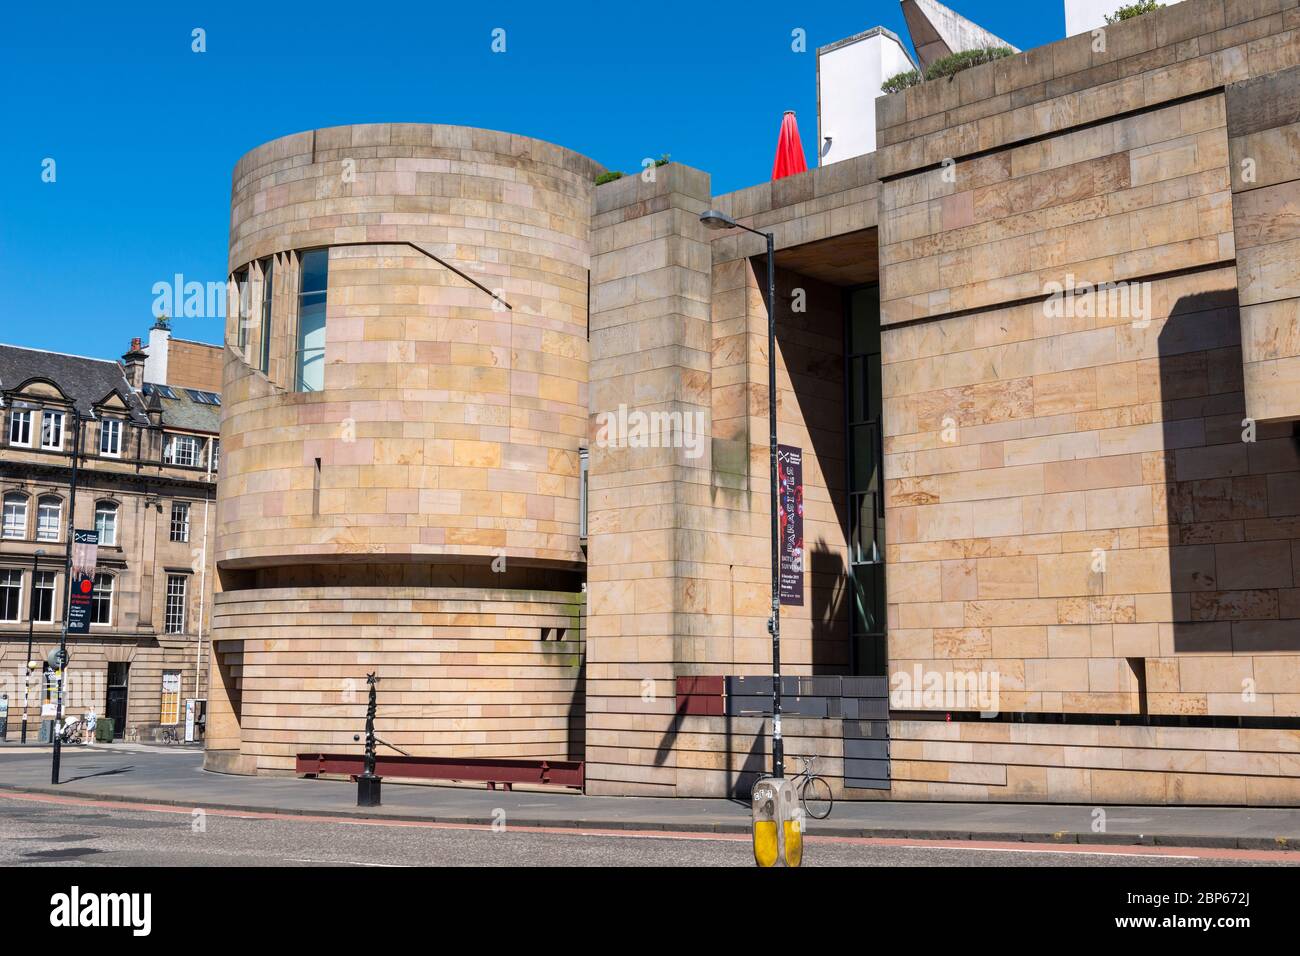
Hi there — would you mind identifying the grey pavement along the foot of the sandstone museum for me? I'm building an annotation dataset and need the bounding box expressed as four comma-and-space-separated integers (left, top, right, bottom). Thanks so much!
0, 744, 1300, 860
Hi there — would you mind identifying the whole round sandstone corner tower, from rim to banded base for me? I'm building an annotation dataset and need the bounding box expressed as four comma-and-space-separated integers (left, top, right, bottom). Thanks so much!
207, 124, 601, 773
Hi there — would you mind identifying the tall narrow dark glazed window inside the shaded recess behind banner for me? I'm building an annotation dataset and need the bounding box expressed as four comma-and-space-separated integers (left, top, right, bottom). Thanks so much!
846, 286, 887, 676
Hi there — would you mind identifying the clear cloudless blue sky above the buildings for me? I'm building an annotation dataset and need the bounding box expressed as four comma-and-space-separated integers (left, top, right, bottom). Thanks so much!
0, 0, 1060, 358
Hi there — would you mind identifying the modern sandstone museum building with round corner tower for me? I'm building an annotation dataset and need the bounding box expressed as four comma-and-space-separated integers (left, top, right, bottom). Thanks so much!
207, 0, 1300, 805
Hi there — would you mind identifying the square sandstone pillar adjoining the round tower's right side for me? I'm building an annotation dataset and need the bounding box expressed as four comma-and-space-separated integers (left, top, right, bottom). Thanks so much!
586, 164, 712, 796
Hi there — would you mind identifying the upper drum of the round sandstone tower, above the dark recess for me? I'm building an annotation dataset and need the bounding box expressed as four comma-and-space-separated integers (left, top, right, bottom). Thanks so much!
218, 125, 597, 570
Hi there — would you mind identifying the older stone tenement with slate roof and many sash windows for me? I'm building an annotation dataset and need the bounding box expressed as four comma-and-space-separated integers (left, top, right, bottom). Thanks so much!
0, 323, 221, 740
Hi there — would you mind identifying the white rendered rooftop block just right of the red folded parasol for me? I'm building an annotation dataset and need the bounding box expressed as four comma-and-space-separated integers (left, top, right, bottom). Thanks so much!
816, 33, 913, 166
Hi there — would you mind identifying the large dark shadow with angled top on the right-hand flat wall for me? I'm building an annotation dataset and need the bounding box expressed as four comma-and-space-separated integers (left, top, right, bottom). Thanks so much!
1164, 289, 1300, 658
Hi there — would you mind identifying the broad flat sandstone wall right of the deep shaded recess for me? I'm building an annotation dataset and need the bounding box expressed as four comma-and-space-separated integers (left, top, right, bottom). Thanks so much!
879, 0, 1300, 803
